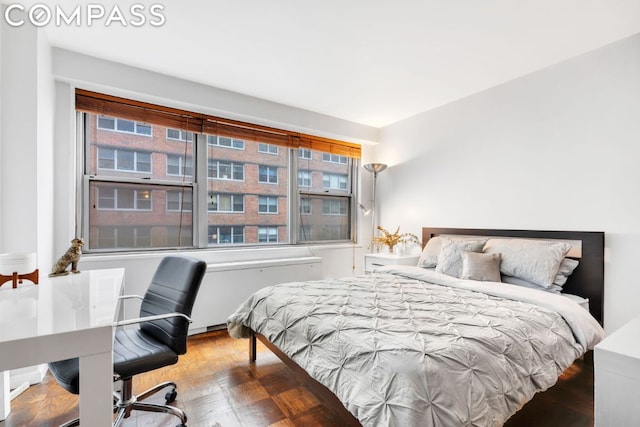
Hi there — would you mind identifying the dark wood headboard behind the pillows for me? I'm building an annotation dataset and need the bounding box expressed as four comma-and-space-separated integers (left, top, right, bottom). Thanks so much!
422, 227, 604, 324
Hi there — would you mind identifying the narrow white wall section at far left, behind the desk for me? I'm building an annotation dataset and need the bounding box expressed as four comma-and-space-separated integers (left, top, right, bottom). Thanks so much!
0, 15, 54, 272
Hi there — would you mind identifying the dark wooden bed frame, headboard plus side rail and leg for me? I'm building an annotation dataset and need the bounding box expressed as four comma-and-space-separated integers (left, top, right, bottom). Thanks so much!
249, 227, 604, 426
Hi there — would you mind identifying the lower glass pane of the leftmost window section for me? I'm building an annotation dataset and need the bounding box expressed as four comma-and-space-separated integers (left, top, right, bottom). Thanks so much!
88, 180, 193, 250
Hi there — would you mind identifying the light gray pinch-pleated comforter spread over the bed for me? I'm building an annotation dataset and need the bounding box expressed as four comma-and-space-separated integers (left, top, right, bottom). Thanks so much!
228, 267, 604, 427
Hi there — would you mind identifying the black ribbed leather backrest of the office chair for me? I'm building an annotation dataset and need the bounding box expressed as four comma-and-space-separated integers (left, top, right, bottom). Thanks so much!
140, 256, 207, 354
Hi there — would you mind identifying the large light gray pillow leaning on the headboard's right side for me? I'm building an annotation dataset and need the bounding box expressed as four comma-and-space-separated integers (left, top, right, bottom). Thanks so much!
483, 239, 571, 288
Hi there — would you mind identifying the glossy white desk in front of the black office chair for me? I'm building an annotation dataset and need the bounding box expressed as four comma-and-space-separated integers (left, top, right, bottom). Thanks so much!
0, 268, 124, 426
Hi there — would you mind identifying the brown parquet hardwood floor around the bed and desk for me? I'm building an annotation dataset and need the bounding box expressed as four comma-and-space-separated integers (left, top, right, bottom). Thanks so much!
0, 331, 593, 427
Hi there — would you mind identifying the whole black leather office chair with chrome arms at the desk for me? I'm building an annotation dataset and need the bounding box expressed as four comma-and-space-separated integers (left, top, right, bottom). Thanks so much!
49, 256, 207, 427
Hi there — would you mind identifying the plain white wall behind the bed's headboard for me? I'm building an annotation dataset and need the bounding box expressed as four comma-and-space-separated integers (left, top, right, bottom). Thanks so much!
375, 35, 640, 332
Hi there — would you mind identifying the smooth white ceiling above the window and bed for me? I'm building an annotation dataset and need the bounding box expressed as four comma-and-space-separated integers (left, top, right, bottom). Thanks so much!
27, 0, 640, 127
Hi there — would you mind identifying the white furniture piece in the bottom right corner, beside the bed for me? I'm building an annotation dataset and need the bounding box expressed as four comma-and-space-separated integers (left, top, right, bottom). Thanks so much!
593, 317, 640, 427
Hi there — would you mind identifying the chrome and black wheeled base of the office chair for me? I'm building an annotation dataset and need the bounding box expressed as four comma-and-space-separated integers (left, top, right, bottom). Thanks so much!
60, 378, 187, 427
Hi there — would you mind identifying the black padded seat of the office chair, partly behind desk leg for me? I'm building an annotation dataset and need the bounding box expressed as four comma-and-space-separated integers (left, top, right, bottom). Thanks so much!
49, 329, 178, 394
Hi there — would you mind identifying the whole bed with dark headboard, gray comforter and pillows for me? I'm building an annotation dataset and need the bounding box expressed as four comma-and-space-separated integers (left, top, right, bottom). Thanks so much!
227, 228, 604, 426
